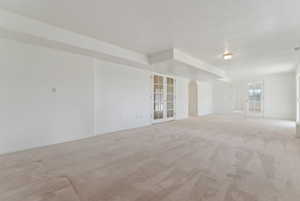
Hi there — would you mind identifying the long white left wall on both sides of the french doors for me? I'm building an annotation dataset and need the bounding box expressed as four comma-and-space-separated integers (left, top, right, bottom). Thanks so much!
0, 39, 189, 154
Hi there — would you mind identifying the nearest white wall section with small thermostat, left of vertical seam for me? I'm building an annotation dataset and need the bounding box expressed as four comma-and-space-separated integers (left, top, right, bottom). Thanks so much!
0, 39, 94, 153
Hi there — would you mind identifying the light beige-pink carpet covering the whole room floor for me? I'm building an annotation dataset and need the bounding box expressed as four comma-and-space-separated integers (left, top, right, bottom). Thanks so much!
0, 115, 300, 201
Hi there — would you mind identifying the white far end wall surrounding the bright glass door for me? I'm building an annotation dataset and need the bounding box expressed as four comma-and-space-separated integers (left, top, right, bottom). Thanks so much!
213, 73, 296, 120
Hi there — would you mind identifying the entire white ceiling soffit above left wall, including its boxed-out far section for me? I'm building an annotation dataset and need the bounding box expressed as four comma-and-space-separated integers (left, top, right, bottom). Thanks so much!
0, 9, 226, 79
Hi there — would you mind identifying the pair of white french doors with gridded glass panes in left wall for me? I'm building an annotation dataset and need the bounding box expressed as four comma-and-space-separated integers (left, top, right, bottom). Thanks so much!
152, 74, 175, 123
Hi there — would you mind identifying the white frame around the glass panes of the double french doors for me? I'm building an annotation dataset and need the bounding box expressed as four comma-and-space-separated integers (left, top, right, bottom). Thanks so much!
150, 73, 176, 124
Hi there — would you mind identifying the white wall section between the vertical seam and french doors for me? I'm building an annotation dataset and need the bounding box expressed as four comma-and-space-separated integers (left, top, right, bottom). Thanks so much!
95, 61, 152, 134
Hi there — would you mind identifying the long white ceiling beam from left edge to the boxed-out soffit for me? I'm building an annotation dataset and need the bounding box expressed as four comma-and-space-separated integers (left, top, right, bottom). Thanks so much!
0, 9, 148, 68
